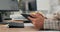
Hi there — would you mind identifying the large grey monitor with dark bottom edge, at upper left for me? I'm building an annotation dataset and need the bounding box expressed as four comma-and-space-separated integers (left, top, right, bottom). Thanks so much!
0, 0, 19, 11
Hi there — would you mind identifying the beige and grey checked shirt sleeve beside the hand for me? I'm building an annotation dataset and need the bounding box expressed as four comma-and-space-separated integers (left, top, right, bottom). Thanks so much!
44, 19, 59, 30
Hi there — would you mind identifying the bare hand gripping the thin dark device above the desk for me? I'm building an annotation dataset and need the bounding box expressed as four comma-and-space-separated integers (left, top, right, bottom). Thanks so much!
28, 13, 44, 29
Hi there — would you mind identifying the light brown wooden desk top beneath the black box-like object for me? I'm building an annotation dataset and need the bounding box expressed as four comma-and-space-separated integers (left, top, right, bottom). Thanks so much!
0, 20, 37, 32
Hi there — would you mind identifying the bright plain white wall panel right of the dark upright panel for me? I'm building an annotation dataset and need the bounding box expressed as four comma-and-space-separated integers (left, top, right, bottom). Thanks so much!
36, 0, 50, 10
